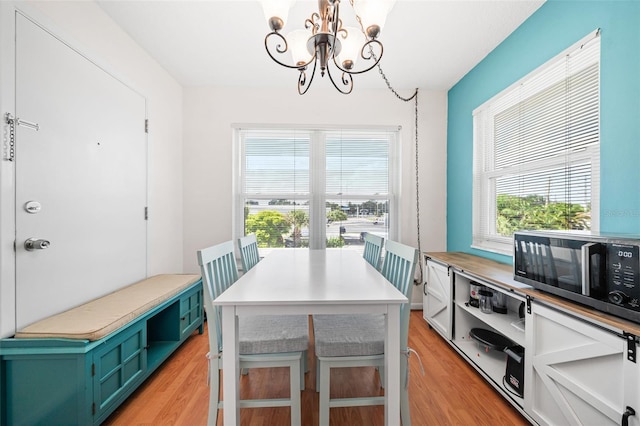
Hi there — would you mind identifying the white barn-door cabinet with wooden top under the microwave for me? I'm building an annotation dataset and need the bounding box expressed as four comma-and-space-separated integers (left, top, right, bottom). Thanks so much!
423, 253, 640, 426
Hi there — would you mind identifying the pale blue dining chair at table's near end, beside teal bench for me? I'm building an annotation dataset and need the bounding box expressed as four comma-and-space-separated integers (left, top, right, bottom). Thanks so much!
198, 241, 309, 426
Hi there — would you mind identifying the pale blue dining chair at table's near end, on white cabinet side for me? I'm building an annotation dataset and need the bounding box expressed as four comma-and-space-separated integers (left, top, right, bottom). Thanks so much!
313, 241, 418, 426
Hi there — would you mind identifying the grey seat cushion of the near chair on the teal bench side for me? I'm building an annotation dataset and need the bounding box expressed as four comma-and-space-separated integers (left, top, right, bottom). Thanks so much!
238, 315, 309, 355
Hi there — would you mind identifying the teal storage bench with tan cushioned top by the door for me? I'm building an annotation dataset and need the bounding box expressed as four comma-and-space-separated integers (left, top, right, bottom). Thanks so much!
0, 275, 203, 425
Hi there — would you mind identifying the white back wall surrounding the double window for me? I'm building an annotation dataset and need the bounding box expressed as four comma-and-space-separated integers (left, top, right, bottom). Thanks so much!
183, 87, 447, 303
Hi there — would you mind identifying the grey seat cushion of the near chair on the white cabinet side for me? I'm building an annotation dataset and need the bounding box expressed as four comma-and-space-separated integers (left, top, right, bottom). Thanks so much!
313, 314, 385, 357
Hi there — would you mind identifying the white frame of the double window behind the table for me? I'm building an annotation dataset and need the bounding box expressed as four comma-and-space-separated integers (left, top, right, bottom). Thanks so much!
232, 124, 400, 252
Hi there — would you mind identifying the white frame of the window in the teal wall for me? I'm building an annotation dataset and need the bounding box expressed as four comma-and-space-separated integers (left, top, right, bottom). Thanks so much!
471, 30, 601, 255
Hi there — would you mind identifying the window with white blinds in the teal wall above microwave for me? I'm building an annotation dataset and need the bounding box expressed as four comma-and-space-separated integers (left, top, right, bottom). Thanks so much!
473, 31, 600, 254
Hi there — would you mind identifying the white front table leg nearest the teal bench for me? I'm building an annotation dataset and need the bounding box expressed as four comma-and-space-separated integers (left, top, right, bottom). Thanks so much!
222, 306, 240, 426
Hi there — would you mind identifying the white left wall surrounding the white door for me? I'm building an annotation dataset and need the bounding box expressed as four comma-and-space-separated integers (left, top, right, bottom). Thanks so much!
0, 1, 183, 336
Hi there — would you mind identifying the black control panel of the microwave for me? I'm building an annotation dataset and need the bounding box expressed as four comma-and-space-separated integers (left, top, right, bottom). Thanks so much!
606, 243, 640, 311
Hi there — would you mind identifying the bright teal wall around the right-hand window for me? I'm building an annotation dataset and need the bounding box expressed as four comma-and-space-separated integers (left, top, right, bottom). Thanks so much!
447, 0, 640, 263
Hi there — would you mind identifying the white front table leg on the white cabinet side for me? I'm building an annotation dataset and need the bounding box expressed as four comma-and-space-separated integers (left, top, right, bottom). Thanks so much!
384, 304, 400, 426
